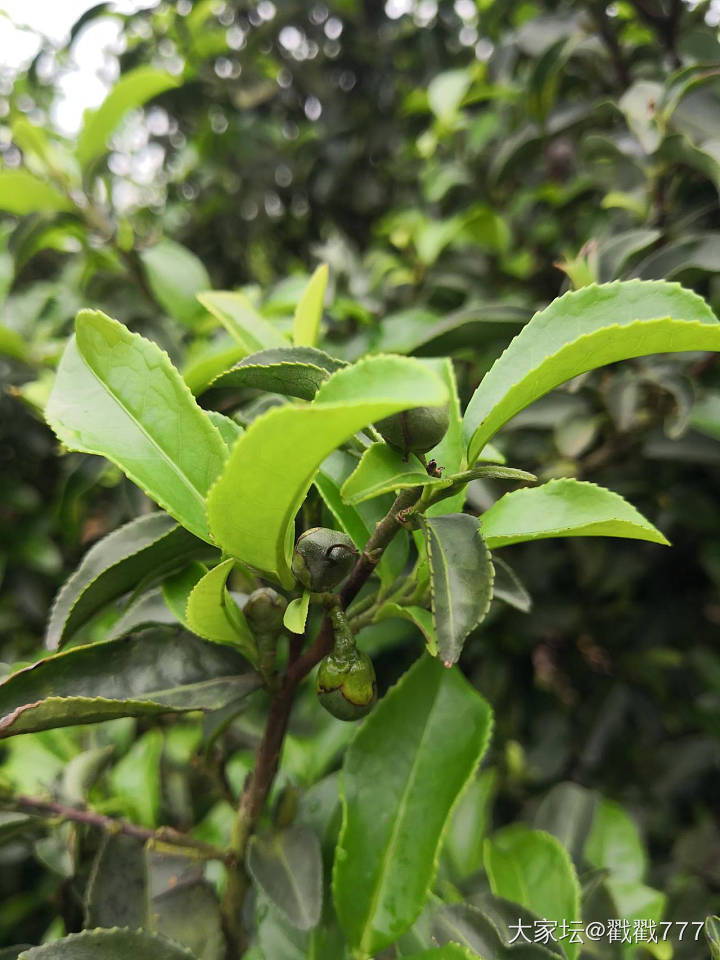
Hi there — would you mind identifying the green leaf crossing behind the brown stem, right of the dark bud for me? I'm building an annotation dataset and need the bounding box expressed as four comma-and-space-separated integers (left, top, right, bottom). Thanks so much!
314, 450, 409, 587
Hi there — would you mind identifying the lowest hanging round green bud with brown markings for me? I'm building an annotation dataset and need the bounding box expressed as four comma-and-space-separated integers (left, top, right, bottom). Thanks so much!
315, 648, 377, 720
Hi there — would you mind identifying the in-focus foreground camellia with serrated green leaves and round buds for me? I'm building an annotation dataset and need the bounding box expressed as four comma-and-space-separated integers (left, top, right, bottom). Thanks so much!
0, 267, 720, 960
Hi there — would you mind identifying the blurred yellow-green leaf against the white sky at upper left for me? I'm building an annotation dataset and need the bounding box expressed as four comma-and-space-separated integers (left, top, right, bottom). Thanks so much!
76, 67, 182, 166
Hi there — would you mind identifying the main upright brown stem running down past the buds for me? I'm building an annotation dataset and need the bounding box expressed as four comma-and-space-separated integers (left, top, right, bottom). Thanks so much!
222, 487, 422, 960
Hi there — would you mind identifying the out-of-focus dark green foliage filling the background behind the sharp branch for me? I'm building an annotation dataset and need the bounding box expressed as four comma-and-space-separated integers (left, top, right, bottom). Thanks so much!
0, 0, 720, 958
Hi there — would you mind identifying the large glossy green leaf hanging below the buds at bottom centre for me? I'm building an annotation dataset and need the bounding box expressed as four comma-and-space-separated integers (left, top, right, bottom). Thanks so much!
333, 656, 491, 956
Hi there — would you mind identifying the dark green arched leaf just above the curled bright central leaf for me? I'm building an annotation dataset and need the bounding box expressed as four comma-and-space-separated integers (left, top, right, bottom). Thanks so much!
209, 347, 347, 400
